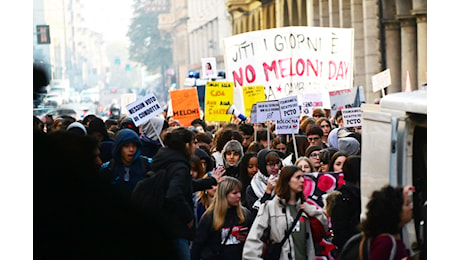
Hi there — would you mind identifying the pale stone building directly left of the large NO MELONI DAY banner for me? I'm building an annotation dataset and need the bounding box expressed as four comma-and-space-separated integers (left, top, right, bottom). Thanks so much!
158, 0, 232, 87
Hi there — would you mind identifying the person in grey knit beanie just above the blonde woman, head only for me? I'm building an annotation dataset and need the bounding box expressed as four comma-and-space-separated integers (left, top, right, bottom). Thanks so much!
222, 140, 244, 178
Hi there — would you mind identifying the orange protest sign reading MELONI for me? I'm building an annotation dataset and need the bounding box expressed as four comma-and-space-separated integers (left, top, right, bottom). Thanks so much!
169, 88, 200, 126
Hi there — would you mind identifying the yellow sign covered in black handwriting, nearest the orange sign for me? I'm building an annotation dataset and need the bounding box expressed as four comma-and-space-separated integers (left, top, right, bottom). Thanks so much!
204, 81, 234, 122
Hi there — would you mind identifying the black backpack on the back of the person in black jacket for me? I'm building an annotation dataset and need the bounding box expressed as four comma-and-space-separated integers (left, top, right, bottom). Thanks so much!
131, 168, 174, 219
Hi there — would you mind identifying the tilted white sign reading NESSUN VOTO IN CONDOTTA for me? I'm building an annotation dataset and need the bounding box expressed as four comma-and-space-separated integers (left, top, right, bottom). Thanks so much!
126, 94, 163, 126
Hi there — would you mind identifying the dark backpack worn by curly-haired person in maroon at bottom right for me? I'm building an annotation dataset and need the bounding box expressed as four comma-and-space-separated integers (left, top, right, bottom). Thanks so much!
337, 233, 397, 260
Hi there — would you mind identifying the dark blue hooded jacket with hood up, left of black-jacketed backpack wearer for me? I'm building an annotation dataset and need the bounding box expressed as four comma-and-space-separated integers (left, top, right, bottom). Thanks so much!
100, 128, 152, 197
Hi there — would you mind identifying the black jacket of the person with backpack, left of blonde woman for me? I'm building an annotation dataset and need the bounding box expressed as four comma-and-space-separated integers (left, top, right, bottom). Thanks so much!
152, 147, 195, 240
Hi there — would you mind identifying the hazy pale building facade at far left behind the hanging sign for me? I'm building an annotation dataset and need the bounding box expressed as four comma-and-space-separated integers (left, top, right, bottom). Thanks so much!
33, 0, 109, 89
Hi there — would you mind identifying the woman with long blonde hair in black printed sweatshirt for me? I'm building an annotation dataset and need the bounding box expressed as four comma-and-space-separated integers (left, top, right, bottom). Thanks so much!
191, 176, 252, 259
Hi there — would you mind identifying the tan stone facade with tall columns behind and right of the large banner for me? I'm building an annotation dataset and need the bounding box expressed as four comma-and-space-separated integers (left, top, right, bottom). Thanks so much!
226, 0, 427, 102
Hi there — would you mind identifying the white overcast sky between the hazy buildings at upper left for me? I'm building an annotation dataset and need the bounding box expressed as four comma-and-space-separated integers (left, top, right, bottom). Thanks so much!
82, 0, 133, 42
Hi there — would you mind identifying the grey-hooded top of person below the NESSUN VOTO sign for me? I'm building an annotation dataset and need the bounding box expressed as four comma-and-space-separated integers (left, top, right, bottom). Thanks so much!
141, 117, 165, 157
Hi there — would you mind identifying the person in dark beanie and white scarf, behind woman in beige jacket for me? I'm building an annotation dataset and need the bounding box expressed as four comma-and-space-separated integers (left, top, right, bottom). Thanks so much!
246, 149, 283, 214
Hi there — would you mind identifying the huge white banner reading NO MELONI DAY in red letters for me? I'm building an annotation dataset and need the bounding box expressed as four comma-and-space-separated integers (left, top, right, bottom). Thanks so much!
224, 26, 354, 100
